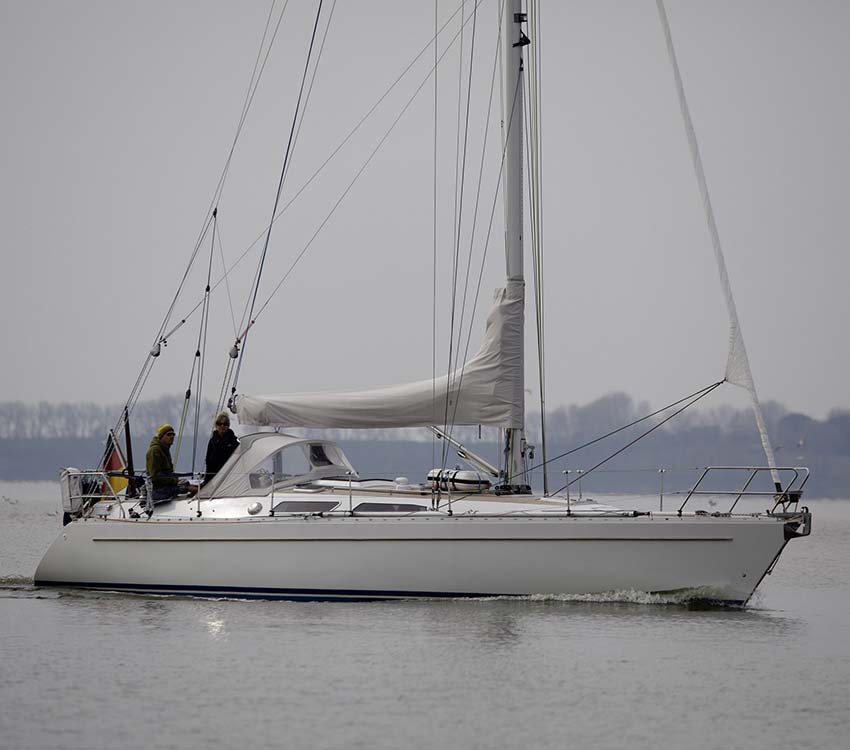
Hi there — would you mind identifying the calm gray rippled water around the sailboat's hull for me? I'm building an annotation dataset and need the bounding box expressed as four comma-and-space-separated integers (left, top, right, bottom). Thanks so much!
0, 482, 850, 750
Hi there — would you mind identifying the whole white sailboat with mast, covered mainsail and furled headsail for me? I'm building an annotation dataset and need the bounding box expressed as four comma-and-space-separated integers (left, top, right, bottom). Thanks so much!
34, 0, 811, 605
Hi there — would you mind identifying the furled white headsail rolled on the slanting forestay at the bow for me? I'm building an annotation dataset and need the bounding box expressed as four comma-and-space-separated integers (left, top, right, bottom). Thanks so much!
656, 0, 782, 491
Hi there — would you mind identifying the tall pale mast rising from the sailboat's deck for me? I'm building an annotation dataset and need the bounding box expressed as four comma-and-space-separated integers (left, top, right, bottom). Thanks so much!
502, 0, 529, 491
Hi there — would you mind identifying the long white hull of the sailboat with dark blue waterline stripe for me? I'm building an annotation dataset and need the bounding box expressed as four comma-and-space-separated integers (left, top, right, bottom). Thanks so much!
35, 513, 786, 603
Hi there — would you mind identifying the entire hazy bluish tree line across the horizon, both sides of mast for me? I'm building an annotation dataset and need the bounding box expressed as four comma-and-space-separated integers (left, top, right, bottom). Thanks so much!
0, 393, 850, 499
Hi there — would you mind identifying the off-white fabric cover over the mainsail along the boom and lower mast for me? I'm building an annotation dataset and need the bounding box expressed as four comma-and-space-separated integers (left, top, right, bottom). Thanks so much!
236, 281, 525, 428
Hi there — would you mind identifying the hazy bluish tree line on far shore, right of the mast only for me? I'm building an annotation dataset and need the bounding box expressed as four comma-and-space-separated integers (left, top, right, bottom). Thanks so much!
529, 393, 850, 499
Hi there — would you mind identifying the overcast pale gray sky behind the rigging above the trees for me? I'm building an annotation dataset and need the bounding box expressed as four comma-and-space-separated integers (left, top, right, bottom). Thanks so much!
0, 0, 850, 424
